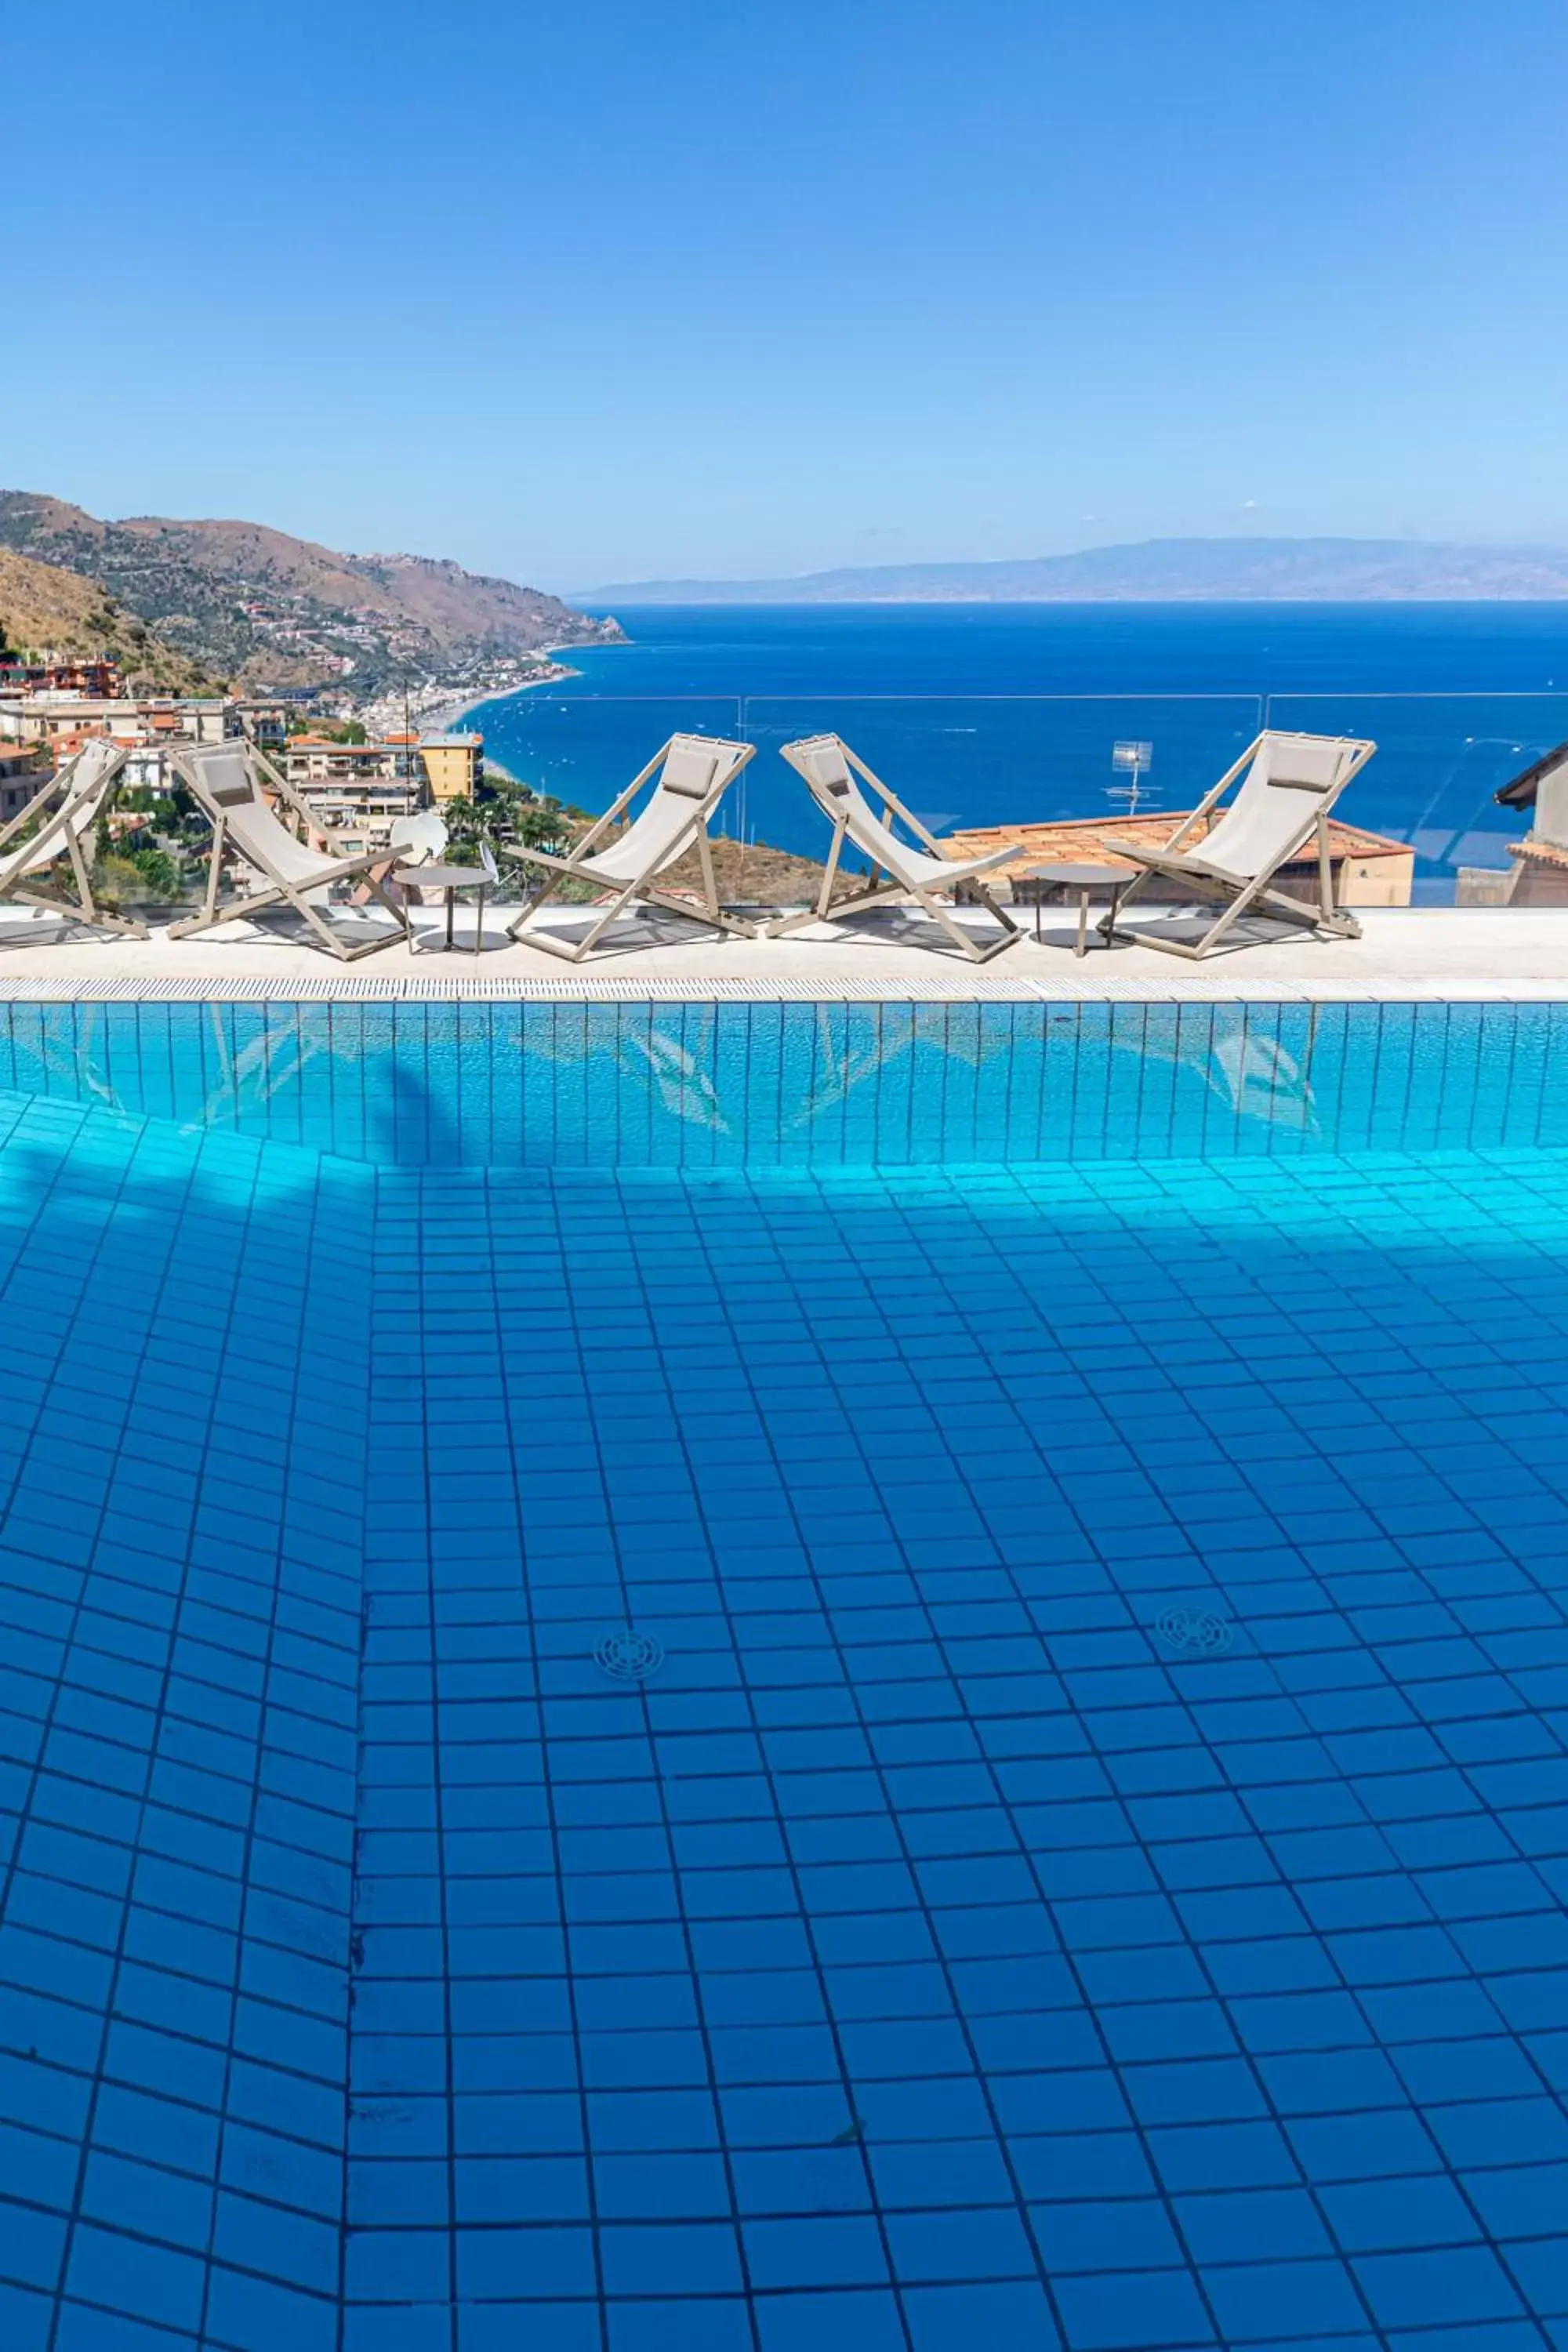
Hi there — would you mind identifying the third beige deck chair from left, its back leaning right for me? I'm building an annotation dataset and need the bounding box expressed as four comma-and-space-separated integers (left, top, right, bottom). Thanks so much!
501, 736, 757, 964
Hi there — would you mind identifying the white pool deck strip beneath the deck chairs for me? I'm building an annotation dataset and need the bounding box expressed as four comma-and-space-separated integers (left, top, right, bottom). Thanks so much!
0, 908, 1568, 1002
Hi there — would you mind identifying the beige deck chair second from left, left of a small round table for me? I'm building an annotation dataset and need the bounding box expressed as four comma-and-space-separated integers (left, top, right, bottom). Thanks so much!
169, 739, 402, 964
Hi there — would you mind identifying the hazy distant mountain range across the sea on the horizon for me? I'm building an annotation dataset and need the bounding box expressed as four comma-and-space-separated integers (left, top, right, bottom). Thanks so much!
567, 539, 1568, 607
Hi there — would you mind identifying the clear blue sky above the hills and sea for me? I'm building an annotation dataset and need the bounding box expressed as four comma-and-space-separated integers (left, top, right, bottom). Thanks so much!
12, 0, 1568, 588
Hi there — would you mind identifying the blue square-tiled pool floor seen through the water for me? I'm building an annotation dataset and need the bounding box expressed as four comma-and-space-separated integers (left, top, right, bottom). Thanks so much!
0, 1096, 1568, 2352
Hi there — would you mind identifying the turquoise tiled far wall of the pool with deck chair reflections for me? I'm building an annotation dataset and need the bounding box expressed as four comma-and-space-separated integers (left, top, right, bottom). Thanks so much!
0, 1000, 1568, 1169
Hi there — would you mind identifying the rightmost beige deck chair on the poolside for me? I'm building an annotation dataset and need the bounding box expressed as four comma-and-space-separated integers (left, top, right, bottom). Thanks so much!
1100, 729, 1377, 957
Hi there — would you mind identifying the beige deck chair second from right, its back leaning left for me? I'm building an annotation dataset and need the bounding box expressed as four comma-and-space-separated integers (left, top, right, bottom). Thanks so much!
764, 736, 1022, 964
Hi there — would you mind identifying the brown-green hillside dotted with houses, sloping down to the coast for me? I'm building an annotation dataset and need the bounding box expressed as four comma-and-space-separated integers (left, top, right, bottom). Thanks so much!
0, 489, 621, 696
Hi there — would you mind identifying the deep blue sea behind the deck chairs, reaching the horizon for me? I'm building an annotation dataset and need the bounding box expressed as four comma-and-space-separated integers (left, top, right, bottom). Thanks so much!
473, 602, 1568, 901
